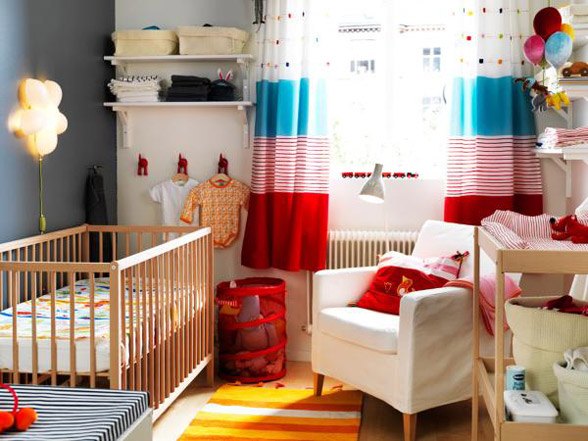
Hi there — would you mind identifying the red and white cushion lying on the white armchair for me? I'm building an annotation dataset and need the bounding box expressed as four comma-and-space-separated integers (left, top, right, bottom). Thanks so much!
357, 251, 468, 315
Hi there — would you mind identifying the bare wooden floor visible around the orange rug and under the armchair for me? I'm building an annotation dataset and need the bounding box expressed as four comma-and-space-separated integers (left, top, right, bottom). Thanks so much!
153, 362, 493, 441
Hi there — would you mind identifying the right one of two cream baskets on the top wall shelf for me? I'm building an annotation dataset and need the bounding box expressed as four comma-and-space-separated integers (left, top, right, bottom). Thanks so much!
178, 26, 249, 55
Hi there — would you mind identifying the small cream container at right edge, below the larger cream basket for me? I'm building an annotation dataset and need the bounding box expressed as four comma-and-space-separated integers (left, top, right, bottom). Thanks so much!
553, 363, 588, 424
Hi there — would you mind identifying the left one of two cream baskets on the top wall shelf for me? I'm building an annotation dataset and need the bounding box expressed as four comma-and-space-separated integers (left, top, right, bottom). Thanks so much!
112, 30, 178, 57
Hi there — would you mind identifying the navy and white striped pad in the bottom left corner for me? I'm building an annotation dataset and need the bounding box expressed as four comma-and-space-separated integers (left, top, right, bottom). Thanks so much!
0, 385, 148, 441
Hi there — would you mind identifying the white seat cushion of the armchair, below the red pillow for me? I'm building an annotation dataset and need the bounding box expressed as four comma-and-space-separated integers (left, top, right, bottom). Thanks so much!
318, 307, 400, 354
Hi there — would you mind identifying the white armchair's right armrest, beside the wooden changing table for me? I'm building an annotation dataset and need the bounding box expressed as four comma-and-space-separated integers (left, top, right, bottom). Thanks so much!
397, 287, 472, 413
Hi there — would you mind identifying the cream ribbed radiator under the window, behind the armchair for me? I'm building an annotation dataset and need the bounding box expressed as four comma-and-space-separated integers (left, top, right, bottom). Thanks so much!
327, 230, 418, 269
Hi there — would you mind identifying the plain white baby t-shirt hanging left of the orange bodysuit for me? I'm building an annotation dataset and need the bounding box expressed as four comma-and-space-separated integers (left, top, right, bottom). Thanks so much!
149, 178, 198, 238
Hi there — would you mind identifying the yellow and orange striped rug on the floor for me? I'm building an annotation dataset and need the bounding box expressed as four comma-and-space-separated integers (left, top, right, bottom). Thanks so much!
179, 385, 362, 441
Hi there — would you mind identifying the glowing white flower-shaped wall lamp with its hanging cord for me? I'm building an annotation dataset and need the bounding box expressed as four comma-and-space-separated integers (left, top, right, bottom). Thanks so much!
9, 78, 67, 233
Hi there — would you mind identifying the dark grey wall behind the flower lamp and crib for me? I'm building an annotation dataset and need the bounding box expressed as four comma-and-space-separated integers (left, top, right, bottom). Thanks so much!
0, 0, 116, 242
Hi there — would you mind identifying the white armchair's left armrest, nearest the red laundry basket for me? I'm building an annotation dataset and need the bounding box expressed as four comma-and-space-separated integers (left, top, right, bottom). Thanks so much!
312, 267, 376, 323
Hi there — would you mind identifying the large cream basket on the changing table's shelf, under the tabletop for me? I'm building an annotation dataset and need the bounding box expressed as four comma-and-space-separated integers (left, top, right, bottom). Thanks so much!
506, 297, 588, 405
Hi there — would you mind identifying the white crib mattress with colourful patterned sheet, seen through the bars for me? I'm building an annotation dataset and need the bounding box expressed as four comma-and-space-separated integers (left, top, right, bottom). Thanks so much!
0, 278, 165, 372
